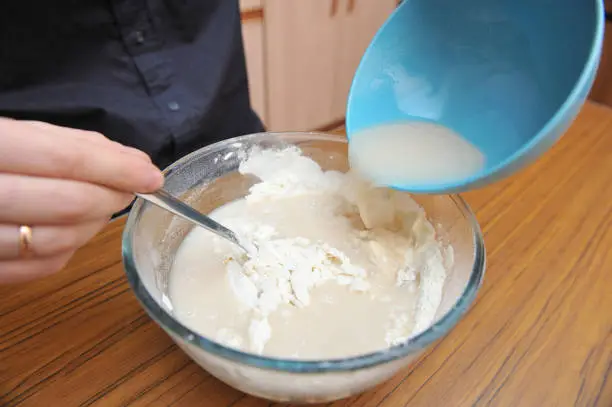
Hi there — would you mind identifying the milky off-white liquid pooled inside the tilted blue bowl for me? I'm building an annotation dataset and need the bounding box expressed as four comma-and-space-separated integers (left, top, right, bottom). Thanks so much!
349, 122, 485, 186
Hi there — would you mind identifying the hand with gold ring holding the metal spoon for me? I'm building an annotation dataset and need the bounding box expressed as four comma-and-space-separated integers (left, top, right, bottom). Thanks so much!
0, 118, 163, 283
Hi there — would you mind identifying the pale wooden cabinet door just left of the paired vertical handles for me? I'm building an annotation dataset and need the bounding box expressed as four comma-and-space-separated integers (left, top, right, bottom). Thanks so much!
264, 0, 340, 131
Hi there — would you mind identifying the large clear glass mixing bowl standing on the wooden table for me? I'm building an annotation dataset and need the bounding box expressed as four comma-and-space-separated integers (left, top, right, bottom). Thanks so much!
123, 133, 485, 403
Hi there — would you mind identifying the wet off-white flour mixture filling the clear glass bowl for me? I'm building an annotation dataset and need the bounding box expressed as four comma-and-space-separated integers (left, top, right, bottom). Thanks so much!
170, 147, 452, 359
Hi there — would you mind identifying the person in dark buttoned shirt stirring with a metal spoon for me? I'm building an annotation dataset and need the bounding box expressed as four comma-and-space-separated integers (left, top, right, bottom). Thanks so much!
0, 0, 263, 282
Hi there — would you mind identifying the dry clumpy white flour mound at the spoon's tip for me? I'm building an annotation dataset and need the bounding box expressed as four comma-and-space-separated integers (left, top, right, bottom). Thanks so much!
227, 233, 370, 353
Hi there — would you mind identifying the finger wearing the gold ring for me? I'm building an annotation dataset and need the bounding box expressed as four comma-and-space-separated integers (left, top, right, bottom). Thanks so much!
0, 219, 108, 261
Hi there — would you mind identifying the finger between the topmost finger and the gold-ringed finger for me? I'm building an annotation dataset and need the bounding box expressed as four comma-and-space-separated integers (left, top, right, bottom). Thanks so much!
0, 173, 133, 225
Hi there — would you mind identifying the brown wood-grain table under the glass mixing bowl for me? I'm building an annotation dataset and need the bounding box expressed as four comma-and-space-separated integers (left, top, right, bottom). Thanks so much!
0, 104, 612, 407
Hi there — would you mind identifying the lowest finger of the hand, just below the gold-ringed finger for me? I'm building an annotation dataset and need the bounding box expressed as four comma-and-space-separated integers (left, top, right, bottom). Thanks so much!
0, 252, 74, 284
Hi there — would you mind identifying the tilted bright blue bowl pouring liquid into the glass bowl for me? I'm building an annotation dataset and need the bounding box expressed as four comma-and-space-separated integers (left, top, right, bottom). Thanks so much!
346, 0, 604, 193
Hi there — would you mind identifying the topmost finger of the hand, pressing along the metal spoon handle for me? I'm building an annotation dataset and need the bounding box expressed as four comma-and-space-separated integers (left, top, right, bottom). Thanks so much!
0, 120, 163, 192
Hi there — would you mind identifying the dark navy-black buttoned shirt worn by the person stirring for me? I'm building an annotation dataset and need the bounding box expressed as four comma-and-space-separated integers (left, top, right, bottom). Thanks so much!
0, 0, 262, 167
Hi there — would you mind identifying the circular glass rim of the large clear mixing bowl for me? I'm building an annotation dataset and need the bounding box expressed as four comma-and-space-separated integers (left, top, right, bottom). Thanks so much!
122, 132, 486, 373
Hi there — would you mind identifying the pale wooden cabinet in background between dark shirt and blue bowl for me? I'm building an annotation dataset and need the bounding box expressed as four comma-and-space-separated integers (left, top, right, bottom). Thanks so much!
241, 0, 397, 131
